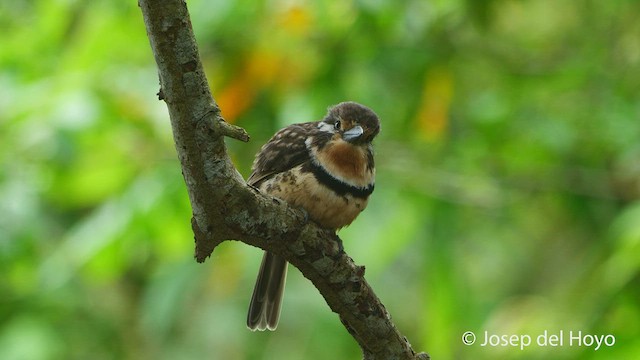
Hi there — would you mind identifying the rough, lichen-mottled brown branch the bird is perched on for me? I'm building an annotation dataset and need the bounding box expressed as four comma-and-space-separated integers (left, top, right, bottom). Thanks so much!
139, 0, 428, 359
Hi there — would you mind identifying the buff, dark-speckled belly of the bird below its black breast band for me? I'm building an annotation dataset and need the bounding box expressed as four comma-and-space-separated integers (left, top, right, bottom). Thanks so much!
260, 166, 368, 229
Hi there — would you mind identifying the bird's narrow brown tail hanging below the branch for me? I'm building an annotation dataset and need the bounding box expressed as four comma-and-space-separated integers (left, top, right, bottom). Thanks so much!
247, 252, 287, 331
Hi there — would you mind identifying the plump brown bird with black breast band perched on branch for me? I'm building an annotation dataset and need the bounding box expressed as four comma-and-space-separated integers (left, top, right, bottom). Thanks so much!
247, 102, 380, 331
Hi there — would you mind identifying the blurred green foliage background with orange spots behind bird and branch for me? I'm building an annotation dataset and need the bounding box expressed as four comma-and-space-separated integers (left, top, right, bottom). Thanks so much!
0, 0, 640, 359
